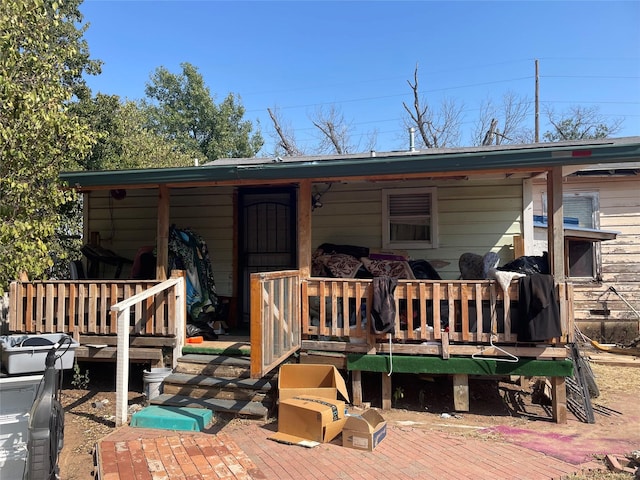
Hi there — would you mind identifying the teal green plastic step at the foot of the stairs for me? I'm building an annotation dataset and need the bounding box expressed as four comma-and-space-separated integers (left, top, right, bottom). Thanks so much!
130, 405, 213, 432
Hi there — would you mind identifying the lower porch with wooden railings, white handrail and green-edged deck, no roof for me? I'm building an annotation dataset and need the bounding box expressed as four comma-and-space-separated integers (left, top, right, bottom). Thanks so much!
9, 270, 573, 424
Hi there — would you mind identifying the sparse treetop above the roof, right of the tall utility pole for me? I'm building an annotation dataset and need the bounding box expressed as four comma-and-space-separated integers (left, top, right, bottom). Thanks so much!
543, 106, 622, 142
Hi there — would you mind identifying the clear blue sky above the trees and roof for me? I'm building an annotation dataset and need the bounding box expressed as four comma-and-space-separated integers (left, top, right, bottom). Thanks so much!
80, 0, 640, 156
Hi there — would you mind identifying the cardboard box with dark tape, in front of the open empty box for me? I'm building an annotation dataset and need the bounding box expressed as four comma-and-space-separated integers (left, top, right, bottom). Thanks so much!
270, 395, 346, 447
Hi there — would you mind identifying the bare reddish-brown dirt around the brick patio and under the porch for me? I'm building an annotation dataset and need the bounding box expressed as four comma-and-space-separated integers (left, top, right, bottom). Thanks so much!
58, 353, 640, 480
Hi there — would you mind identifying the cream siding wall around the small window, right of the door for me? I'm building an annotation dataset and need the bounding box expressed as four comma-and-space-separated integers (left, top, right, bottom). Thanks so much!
311, 179, 522, 279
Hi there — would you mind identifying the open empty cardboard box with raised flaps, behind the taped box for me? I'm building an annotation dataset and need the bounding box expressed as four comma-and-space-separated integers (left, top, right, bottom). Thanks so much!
278, 363, 349, 402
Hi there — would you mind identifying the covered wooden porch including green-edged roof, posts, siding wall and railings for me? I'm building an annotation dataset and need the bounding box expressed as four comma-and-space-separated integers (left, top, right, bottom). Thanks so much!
10, 141, 637, 422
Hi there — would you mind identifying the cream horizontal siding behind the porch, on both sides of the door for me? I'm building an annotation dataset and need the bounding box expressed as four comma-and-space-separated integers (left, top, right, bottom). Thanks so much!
85, 178, 522, 296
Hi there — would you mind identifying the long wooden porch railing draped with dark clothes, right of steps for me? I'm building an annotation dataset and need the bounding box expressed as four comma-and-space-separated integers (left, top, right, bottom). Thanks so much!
302, 278, 573, 353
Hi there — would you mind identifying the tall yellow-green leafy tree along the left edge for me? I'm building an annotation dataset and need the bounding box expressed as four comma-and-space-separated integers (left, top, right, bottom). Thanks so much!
0, 0, 99, 290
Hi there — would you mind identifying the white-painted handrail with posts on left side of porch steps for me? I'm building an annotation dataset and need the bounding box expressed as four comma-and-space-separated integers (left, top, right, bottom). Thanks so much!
110, 276, 187, 427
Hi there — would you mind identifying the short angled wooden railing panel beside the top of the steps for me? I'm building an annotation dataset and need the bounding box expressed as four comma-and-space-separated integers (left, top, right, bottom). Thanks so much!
251, 270, 301, 378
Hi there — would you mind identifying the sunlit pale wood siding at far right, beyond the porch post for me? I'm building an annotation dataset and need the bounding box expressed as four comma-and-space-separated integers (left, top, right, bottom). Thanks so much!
533, 176, 640, 343
